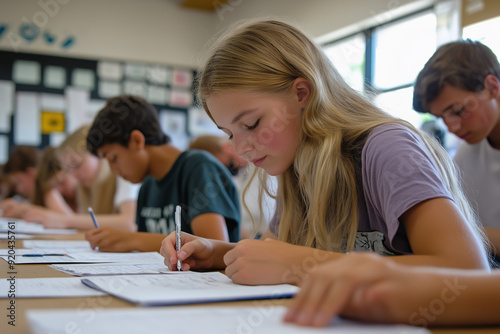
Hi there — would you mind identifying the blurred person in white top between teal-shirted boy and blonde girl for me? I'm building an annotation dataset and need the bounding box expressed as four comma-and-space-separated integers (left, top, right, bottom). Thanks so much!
189, 135, 276, 239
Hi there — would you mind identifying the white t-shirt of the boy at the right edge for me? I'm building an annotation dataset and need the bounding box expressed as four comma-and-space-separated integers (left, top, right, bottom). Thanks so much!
454, 139, 500, 228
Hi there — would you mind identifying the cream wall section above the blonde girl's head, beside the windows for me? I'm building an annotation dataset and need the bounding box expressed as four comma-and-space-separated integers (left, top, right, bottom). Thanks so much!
207, 0, 439, 42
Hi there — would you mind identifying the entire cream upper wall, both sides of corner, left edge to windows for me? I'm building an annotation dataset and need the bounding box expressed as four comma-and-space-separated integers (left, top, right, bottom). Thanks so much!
0, 0, 437, 67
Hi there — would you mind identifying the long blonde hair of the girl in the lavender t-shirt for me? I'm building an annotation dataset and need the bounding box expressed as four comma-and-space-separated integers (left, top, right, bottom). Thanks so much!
198, 20, 481, 251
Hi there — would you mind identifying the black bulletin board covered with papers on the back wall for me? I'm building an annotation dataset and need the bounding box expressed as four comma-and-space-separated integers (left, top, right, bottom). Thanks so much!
0, 50, 219, 164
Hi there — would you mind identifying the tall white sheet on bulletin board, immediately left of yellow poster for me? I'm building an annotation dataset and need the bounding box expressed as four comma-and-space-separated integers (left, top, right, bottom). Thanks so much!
14, 92, 41, 146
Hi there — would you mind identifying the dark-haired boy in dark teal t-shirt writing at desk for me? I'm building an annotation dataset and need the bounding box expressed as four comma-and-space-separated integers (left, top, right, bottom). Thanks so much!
86, 95, 240, 252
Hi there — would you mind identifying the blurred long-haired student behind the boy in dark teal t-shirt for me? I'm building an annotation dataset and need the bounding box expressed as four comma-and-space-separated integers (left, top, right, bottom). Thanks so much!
24, 126, 139, 231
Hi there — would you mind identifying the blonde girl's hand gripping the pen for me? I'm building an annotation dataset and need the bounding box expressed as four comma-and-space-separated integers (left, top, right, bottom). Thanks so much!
160, 232, 217, 271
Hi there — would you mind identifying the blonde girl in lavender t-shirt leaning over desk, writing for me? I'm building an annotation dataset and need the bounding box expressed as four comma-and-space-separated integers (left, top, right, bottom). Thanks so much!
161, 21, 489, 284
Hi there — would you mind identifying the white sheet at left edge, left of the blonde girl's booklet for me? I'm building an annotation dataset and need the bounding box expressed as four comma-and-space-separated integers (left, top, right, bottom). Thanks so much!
0, 277, 106, 298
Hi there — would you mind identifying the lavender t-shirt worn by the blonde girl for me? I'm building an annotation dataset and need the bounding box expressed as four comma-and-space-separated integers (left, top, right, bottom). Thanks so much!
270, 123, 452, 255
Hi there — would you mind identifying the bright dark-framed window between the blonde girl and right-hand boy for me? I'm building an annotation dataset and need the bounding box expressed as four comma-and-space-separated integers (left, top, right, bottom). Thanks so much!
324, 5, 458, 133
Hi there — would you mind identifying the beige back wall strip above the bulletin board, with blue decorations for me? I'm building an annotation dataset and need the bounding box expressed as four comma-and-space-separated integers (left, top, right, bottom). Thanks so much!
0, 0, 215, 67
